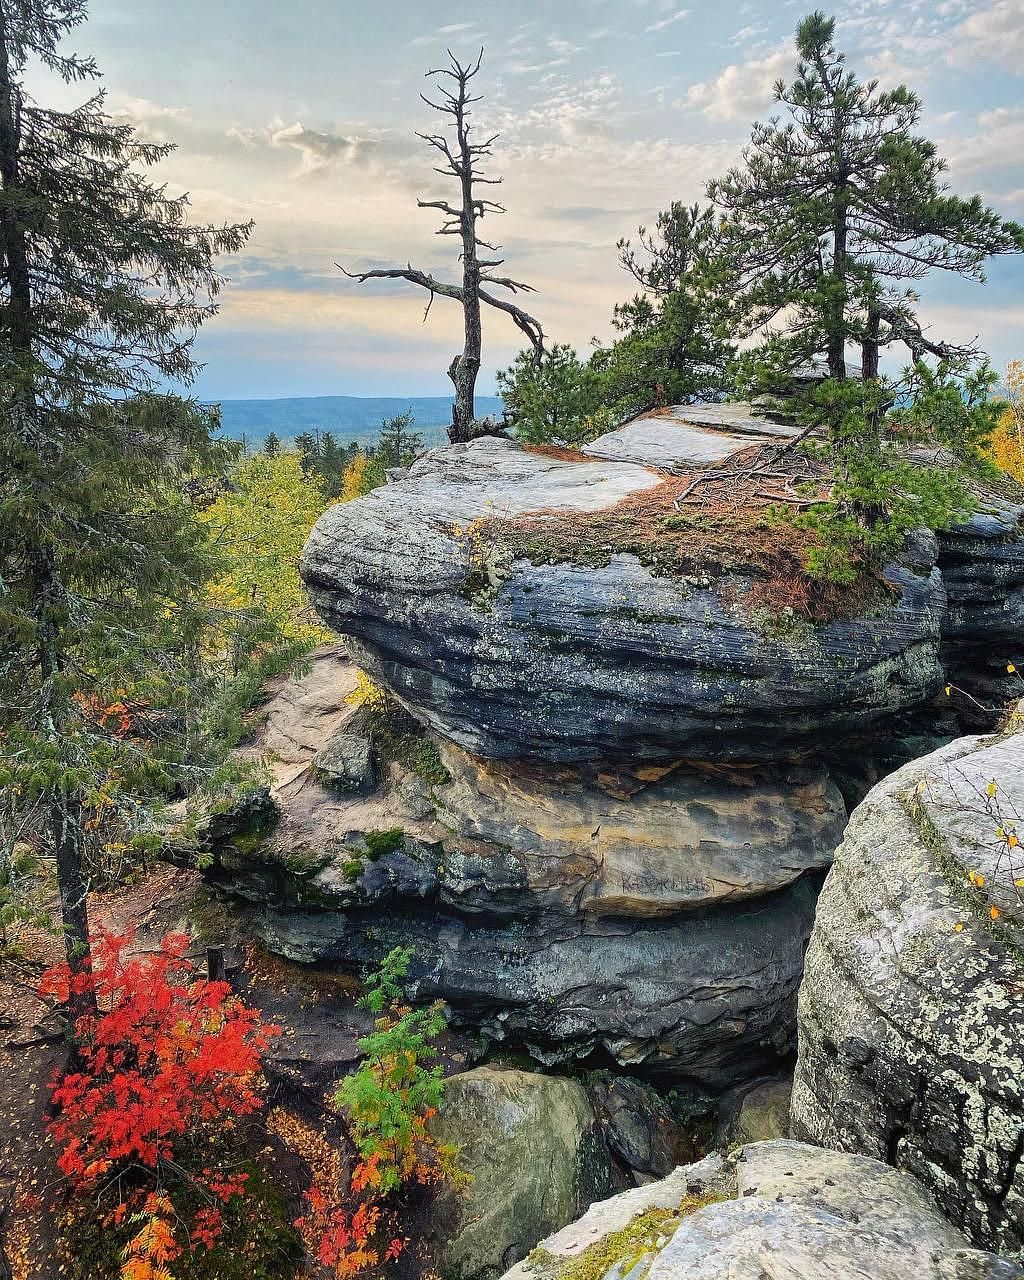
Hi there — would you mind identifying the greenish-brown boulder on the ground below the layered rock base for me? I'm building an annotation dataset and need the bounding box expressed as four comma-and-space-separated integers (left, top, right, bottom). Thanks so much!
431, 1068, 621, 1280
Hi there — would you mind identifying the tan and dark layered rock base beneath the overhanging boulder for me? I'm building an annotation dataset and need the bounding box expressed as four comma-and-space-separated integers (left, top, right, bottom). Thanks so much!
198, 650, 845, 1089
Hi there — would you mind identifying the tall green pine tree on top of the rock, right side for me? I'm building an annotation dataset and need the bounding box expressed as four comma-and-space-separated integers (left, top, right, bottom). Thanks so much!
709, 12, 1024, 380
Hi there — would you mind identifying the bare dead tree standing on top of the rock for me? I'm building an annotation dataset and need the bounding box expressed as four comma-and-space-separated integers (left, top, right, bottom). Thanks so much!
338, 49, 544, 442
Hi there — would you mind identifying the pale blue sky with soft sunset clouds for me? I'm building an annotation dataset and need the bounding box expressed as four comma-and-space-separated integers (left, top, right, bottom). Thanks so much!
33, 0, 1024, 399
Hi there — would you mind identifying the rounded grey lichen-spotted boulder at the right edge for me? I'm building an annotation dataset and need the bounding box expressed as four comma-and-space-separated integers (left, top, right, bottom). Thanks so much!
792, 733, 1024, 1254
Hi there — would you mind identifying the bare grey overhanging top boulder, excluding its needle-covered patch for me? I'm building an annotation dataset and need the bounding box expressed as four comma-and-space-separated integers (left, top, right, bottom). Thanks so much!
301, 436, 945, 762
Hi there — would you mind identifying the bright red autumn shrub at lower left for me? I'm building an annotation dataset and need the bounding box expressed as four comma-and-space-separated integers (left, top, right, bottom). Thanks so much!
40, 933, 278, 1280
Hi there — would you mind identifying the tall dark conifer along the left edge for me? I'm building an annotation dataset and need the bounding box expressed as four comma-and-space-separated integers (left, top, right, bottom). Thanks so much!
0, 0, 248, 1000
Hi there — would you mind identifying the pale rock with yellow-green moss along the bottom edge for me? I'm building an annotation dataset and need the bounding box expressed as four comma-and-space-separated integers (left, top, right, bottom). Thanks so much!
504, 1140, 1024, 1280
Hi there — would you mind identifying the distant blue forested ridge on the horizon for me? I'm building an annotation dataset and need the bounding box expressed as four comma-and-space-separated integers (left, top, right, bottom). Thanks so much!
220, 396, 502, 444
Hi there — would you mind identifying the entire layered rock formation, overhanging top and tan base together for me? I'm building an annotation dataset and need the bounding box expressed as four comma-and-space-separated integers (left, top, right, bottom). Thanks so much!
199, 406, 1024, 1089
